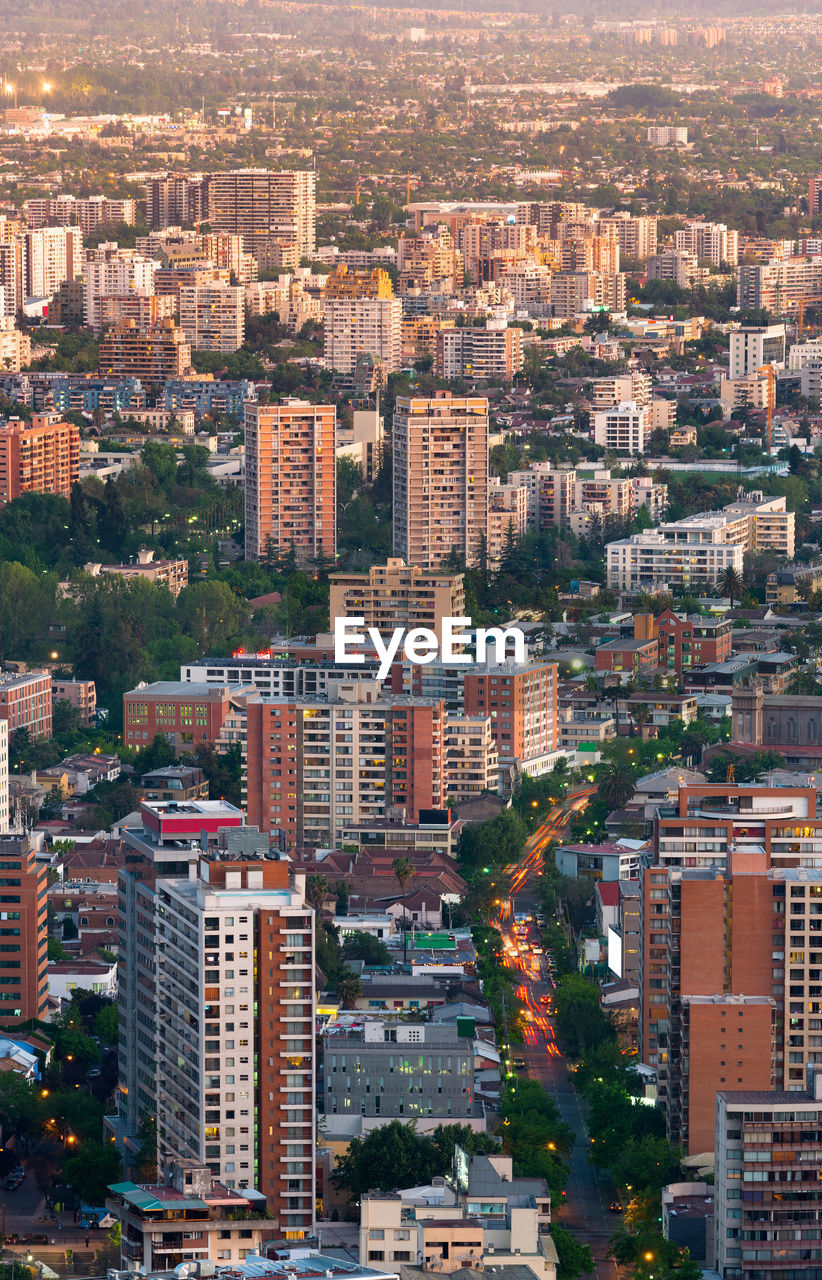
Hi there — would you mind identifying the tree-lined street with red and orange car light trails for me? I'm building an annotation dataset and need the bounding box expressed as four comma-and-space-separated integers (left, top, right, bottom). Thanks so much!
490, 787, 620, 1280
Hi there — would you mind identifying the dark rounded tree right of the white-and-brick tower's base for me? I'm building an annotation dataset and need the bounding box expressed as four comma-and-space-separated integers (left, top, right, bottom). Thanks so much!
332, 1120, 439, 1201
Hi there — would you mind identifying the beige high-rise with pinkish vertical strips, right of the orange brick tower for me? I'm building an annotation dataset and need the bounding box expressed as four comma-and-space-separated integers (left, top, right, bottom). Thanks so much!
394, 392, 488, 568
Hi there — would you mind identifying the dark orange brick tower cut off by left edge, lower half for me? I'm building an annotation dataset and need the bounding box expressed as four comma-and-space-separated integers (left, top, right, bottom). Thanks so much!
0, 836, 49, 1023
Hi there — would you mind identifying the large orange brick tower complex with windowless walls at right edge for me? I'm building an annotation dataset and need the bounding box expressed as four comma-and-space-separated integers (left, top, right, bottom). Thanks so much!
639, 786, 822, 1155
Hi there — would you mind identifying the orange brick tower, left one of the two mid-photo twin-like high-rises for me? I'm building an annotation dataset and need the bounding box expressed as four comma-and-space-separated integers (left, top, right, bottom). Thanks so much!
246, 401, 337, 564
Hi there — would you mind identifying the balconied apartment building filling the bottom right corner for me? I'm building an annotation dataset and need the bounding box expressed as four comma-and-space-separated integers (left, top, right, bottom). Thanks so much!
713, 1068, 822, 1280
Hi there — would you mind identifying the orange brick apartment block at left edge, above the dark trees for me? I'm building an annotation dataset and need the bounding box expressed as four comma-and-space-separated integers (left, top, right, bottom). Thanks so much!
0, 413, 79, 506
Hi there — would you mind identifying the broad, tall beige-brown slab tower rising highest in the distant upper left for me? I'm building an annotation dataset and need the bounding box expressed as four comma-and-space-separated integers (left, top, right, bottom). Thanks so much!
209, 169, 316, 260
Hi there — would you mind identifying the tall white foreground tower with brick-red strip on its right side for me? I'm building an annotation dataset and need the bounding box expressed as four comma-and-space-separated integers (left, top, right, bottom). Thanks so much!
155, 859, 315, 1228
